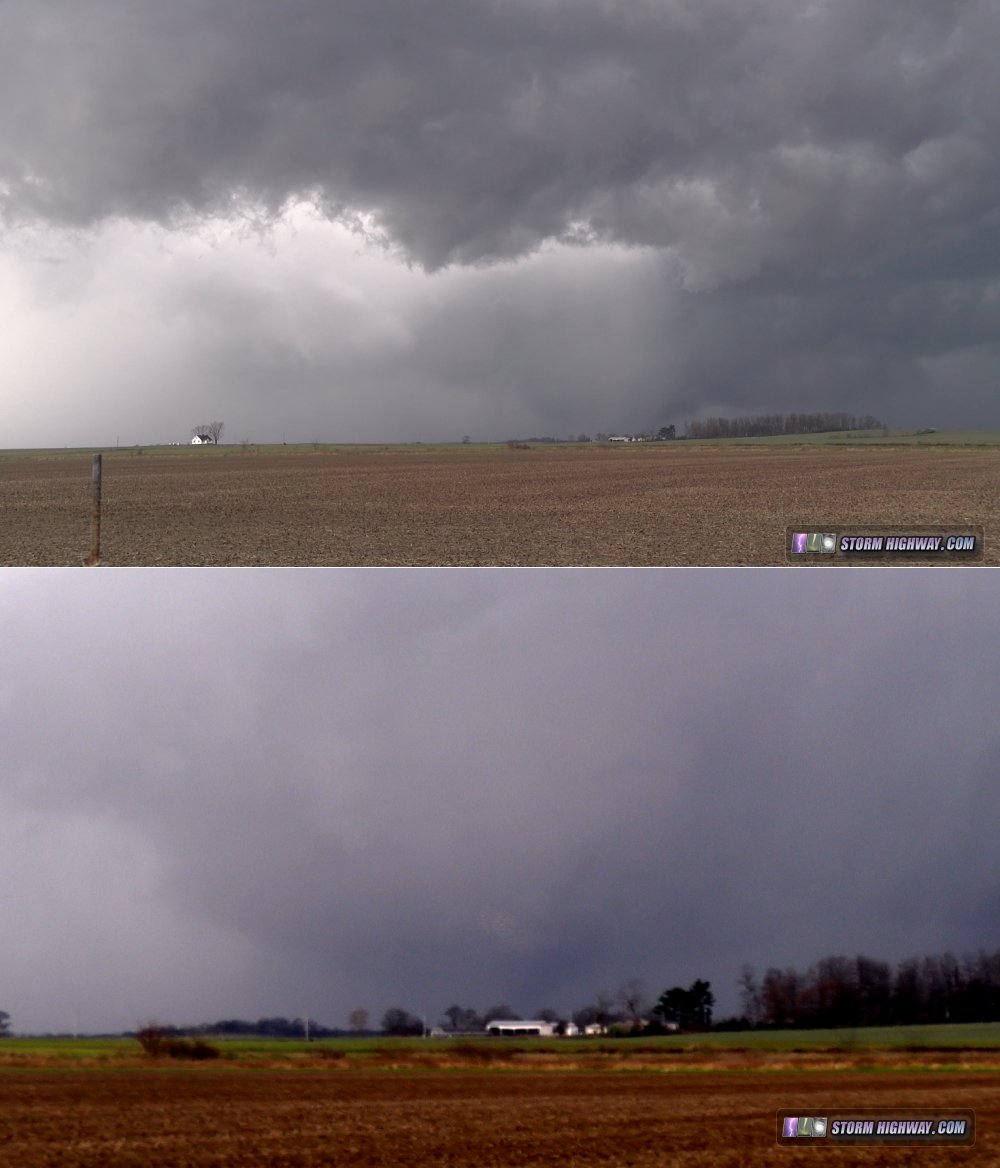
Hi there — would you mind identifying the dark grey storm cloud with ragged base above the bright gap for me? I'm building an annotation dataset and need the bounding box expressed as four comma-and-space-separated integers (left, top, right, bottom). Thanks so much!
0, 0, 1000, 276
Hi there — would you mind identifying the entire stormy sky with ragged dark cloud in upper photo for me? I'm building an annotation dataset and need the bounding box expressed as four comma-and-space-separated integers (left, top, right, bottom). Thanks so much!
0, 0, 1000, 446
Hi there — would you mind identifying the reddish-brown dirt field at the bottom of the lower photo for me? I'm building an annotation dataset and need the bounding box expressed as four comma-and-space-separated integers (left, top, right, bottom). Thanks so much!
0, 1069, 1000, 1168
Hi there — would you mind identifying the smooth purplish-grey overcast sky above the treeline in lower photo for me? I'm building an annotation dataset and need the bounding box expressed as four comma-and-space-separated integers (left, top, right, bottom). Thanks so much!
0, 569, 1000, 1031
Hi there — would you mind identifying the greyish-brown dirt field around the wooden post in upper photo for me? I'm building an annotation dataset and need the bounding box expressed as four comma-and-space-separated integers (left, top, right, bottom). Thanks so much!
0, 444, 1000, 565
